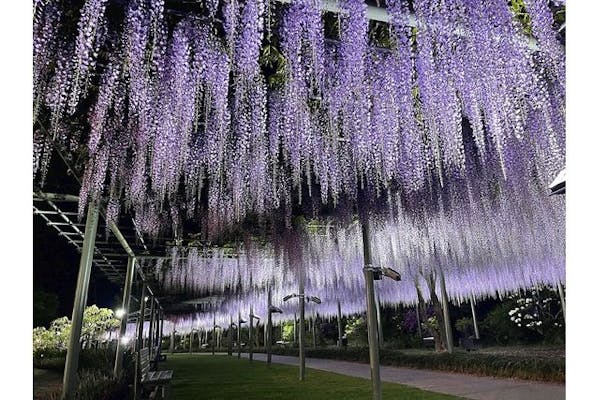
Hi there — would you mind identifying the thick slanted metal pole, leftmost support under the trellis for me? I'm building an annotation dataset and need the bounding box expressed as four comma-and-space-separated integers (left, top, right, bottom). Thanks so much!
61, 202, 98, 399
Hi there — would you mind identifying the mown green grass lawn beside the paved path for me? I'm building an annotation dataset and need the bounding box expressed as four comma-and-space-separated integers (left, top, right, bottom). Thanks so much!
161, 354, 459, 400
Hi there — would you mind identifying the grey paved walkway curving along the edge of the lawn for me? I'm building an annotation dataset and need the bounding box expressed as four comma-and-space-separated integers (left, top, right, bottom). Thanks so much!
243, 354, 565, 400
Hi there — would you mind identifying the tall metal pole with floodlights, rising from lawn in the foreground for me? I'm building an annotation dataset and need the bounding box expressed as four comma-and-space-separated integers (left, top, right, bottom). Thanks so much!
362, 218, 381, 400
